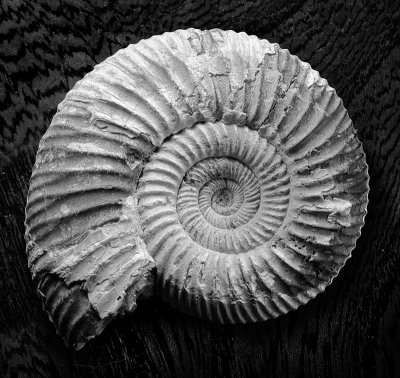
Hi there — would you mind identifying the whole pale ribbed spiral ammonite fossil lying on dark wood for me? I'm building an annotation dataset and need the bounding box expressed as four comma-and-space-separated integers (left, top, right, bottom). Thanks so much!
26, 29, 368, 348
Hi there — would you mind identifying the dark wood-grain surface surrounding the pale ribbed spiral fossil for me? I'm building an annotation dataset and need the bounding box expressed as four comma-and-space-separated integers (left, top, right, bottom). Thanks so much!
0, 0, 400, 377
